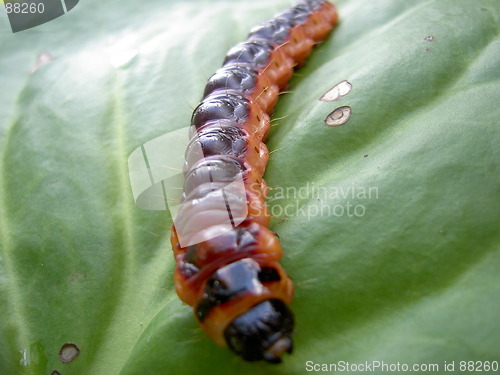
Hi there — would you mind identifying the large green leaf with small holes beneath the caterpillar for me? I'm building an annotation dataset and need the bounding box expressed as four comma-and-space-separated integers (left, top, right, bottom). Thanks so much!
0, 0, 500, 375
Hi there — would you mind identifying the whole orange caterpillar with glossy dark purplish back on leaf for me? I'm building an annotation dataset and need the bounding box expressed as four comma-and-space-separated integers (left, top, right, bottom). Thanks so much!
171, 0, 337, 363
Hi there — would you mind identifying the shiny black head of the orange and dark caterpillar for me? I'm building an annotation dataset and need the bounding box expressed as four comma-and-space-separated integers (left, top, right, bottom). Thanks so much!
224, 299, 294, 363
